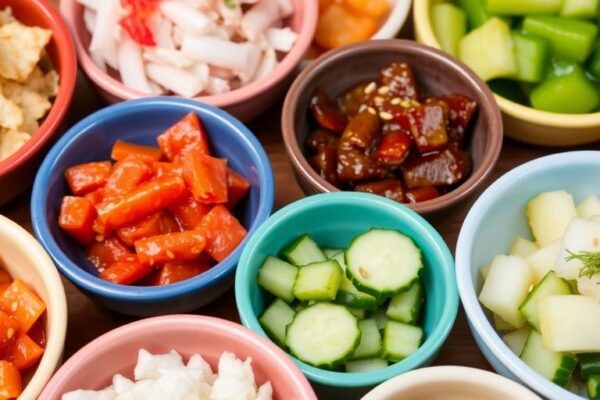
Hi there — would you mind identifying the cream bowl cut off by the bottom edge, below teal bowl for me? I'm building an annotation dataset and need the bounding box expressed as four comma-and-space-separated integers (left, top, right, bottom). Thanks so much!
362, 367, 541, 400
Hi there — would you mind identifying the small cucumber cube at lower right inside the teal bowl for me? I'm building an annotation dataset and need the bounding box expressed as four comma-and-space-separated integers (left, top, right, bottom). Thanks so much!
383, 320, 423, 361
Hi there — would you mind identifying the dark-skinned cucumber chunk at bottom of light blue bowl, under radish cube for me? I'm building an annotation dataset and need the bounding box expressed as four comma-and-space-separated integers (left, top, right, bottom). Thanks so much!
521, 330, 577, 387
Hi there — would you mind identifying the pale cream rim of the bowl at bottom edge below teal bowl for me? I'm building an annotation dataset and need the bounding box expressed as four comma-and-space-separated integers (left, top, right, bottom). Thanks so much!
362, 366, 541, 400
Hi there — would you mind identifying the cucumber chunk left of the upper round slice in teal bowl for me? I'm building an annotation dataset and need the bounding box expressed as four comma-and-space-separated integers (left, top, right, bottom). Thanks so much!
293, 260, 342, 300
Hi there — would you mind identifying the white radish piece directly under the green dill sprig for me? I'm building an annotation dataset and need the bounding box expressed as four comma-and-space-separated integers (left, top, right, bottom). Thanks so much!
554, 218, 600, 279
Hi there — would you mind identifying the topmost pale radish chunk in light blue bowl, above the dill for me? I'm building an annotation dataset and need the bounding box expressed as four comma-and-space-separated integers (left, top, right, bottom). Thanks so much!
526, 190, 577, 246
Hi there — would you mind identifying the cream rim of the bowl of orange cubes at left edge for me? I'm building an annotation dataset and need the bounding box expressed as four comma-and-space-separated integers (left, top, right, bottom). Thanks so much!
0, 215, 68, 400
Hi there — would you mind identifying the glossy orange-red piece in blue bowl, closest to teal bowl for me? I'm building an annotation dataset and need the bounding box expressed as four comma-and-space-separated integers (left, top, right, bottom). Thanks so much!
198, 205, 248, 262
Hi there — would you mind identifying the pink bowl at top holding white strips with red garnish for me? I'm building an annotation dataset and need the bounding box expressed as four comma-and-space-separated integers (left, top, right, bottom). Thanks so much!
60, 0, 319, 121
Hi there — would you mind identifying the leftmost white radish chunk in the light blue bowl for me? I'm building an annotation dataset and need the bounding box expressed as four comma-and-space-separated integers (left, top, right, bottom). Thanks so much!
479, 255, 533, 328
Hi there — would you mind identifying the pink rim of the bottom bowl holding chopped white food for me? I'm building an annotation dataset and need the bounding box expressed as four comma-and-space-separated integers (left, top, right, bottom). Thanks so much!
39, 314, 317, 400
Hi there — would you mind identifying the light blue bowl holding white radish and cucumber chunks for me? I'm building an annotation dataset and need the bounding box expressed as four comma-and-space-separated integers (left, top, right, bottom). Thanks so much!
456, 151, 600, 400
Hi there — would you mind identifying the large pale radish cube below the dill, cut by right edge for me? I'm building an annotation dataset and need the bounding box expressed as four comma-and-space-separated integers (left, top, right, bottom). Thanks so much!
539, 295, 600, 353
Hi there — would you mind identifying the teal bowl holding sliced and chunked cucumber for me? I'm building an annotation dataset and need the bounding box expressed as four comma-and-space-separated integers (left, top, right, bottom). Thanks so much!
235, 192, 458, 393
